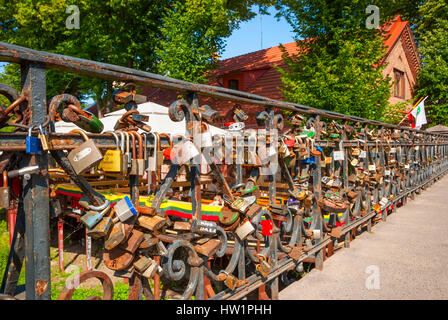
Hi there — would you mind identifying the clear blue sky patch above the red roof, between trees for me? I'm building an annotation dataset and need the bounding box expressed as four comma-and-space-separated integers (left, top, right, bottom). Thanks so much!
221, 7, 294, 59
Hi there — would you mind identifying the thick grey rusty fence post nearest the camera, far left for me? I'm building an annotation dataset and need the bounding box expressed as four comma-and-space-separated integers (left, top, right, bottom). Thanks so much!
22, 63, 51, 300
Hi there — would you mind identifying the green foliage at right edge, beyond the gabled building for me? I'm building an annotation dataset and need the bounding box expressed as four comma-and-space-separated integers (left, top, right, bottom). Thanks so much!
416, 0, 448, 126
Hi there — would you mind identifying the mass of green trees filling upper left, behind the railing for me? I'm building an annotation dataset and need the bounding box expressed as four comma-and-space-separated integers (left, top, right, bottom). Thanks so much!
0, 0, 269, 111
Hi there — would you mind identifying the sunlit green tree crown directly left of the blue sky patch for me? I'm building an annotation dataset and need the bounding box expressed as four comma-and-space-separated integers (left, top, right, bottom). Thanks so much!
156, 0, 270, 83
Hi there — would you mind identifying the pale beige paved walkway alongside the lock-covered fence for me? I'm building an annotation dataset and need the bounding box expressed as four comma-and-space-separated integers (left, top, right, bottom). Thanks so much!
279, 176, 448, 300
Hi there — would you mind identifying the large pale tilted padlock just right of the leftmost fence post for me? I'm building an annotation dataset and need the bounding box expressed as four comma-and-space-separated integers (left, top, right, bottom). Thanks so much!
67, 129, 103, 174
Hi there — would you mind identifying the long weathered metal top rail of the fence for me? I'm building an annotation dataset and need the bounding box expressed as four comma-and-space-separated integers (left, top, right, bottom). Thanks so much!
0, 42, 444, 134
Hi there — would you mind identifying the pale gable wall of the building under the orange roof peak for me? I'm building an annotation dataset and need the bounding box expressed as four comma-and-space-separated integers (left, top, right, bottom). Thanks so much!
383, 38, 416, 104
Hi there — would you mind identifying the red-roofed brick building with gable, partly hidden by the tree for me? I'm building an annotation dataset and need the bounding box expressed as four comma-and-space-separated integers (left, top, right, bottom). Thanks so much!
138, 16, 422, 125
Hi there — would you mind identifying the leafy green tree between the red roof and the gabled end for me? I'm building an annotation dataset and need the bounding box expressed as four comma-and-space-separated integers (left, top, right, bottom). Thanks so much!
279, 0, 390, 119
